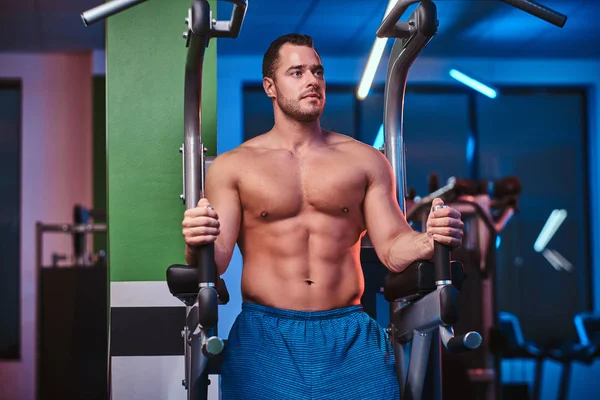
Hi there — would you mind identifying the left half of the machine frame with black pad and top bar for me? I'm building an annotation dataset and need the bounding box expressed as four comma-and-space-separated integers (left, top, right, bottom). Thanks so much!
81, 0, 248, 400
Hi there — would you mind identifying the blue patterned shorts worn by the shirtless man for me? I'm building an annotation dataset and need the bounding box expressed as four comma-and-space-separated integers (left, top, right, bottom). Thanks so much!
221, 303, 399, 400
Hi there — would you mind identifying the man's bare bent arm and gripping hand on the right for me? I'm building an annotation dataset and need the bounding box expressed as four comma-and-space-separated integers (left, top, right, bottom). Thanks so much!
364, 150, 463, 272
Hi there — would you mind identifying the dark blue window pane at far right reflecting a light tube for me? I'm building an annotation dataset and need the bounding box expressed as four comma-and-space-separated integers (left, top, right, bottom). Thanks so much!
477, 90, 590, 343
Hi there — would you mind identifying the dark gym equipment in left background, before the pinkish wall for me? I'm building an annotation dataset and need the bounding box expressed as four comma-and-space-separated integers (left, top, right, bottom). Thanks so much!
36, 205, 108, 400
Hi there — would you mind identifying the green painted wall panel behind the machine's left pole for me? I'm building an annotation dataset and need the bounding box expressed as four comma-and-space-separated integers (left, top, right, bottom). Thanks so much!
106, 0, 217, 282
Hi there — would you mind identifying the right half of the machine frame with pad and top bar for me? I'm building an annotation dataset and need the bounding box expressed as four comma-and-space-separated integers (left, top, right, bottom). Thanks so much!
377, 0, 566, 399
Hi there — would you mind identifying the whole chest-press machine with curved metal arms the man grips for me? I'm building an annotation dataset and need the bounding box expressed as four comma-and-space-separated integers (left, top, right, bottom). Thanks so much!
82, 0, 566, 400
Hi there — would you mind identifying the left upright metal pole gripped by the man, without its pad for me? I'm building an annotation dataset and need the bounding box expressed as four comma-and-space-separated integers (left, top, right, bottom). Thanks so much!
182, 0, 247, 400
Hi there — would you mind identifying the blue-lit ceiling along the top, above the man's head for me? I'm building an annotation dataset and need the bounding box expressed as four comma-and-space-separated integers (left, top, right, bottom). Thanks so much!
0, 0, 600, 58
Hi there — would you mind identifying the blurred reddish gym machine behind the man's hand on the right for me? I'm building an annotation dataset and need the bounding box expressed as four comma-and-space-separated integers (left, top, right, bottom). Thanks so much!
406, 175, 521, 399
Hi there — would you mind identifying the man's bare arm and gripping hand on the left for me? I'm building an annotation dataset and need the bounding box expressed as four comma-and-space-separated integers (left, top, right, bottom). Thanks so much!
184, 153, 242, 275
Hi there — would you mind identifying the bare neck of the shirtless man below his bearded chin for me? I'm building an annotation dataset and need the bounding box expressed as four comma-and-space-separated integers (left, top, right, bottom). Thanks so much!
271, 117, 325, 153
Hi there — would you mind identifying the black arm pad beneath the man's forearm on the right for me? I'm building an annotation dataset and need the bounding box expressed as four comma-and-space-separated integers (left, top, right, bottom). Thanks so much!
383, 260, 465, 302
